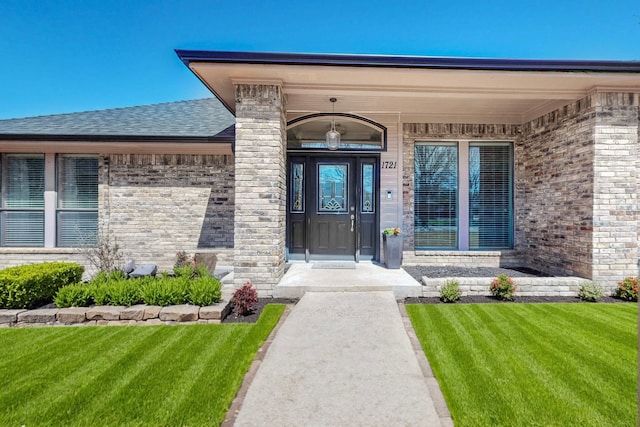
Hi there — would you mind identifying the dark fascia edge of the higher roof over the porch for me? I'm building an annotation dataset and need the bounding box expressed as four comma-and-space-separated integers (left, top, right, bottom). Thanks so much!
176, 49, 640, 73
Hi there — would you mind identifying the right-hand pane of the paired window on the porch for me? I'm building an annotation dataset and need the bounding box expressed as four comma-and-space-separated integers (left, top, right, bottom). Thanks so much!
469, 143, 513, 249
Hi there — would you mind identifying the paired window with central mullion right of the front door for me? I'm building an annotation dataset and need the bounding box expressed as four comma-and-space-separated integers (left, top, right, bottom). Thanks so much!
414, 141, 513, 250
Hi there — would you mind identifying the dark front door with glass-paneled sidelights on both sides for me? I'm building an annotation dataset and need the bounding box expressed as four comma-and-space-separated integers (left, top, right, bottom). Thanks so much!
287, 155, 378, 261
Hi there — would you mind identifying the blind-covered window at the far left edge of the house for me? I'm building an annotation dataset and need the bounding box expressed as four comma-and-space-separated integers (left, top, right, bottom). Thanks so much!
0, 154, 44, 247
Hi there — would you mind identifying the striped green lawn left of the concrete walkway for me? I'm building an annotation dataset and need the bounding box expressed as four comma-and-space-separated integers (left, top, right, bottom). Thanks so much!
0, 304, 284, 426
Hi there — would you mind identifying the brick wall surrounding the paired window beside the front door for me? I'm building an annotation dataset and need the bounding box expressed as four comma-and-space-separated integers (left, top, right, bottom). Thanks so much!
402, 123, 523, 267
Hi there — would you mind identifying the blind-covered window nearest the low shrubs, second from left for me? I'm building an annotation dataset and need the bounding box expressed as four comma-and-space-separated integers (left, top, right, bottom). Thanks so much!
56, 155, 98, 247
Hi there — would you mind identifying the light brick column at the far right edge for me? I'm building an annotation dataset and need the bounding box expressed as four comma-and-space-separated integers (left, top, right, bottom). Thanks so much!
593, 93, 640, 287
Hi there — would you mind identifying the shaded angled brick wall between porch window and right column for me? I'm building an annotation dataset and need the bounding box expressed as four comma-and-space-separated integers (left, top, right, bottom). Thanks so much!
516, 96, 596, 278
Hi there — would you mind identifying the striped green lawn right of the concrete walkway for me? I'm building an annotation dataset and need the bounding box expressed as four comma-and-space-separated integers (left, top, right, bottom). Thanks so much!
407, 304, 638, 427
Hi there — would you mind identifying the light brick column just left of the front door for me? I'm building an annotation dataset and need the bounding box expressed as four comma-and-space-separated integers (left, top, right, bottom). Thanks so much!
234, 83, 287, 296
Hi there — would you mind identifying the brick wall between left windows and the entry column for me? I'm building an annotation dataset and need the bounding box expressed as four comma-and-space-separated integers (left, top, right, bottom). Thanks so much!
99, 154, 235, 270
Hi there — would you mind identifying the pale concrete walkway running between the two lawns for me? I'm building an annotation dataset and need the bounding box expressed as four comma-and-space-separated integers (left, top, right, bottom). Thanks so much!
235, 291, 453, 426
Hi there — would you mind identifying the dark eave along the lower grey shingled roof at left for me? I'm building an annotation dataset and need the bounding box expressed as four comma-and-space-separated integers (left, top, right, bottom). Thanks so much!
0, 134, 234, 144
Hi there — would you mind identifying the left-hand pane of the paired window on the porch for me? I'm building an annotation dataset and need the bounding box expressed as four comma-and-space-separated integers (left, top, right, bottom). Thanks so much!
414, 144, 458, 249
